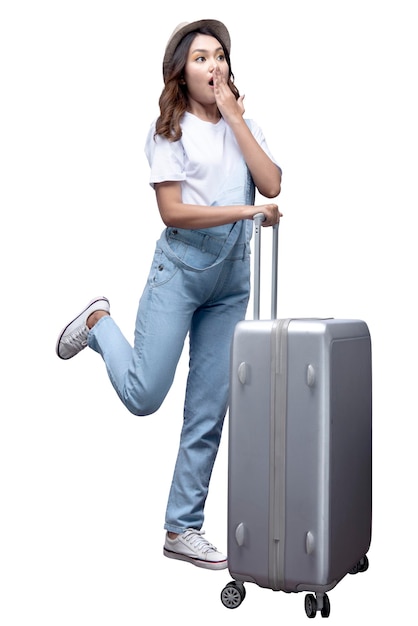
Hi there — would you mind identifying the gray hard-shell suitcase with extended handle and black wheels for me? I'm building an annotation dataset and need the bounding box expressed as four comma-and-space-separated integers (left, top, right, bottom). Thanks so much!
221, 215, 372, 617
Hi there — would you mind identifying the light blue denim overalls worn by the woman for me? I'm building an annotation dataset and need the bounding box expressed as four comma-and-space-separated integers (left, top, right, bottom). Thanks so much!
88, 162, 254, 533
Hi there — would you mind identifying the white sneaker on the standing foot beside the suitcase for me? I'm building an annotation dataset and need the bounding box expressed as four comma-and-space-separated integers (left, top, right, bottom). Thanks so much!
164, 528, 228, 569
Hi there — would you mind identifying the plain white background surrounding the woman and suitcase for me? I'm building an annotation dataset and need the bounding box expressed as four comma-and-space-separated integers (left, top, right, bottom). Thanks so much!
0, 0, 418, 626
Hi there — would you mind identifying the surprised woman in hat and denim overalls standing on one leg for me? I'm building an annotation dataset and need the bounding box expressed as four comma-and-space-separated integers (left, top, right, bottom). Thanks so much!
56, 20, 281, 569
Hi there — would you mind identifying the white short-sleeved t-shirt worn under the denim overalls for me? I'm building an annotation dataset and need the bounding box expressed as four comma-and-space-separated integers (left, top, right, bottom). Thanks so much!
145, 112, 275, 206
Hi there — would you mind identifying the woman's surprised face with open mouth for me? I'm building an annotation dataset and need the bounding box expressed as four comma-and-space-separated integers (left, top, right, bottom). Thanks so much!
184, 34, 229, 105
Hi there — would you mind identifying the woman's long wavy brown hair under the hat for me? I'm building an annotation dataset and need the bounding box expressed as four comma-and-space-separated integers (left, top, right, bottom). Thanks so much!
155, 27, 239, 141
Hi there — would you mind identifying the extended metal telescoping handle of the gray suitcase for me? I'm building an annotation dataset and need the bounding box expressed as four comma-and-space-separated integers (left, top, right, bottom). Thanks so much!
253, 213, 279, 320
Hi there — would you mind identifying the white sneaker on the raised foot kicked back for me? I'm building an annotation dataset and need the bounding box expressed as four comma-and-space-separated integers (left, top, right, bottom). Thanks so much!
55, 298, 110, 359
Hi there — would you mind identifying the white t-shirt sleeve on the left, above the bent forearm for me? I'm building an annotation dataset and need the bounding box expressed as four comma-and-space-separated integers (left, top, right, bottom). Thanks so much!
145, 124, 186, 187
